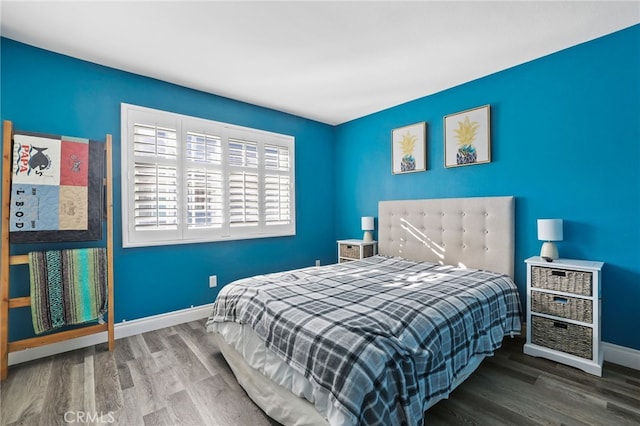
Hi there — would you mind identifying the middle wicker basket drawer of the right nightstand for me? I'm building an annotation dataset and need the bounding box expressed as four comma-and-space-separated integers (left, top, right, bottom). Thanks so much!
531, 290, 593, 323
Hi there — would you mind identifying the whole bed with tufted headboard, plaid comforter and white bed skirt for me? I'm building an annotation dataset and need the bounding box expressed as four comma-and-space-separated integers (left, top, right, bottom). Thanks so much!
206, 197, 522, 425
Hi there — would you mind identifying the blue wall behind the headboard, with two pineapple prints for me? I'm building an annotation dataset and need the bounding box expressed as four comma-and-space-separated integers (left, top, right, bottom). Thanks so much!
336, 25, 640, 349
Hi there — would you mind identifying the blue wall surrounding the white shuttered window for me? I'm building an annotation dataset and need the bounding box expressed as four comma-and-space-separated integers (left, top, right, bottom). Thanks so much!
0, 38, 336, 340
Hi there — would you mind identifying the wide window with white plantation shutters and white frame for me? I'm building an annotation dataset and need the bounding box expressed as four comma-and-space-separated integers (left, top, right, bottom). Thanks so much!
122, 104, 295, 247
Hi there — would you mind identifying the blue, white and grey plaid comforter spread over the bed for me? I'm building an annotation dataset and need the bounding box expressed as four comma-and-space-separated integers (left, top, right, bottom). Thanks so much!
208, 256, 521, 425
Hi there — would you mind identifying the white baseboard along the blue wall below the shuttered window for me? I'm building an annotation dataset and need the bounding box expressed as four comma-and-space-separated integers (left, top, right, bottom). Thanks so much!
9, 303, 213, 365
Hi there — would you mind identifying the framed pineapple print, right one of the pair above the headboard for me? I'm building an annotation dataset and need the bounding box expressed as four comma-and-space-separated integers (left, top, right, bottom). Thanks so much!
444, 105, 491, 167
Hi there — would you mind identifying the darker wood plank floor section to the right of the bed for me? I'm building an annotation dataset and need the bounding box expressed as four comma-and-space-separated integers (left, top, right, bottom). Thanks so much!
425, 338, 640, 426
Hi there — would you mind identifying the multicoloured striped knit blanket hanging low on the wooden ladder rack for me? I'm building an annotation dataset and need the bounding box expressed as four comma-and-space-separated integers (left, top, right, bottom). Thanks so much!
29, 248, 107, 334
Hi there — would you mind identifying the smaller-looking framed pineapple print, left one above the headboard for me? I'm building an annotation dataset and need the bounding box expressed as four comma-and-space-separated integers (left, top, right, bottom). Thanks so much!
391, 121, 427, 175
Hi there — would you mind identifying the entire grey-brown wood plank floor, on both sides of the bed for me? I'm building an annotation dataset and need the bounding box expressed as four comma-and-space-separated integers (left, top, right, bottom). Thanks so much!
0, 321, 640, 426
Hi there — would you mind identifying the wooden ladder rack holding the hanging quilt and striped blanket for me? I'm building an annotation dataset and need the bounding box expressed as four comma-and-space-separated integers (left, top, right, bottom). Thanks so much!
0, 121, 115, 380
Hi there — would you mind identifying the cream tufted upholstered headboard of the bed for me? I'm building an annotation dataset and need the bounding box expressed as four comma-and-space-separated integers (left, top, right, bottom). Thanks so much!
378, 197, 515, 277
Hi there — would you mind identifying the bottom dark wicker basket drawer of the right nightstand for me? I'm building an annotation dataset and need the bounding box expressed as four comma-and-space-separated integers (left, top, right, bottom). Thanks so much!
531, 315, 593, 359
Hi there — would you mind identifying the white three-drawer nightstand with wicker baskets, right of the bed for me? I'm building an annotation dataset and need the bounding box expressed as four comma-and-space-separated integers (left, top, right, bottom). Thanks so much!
524, 256, 604, 376
